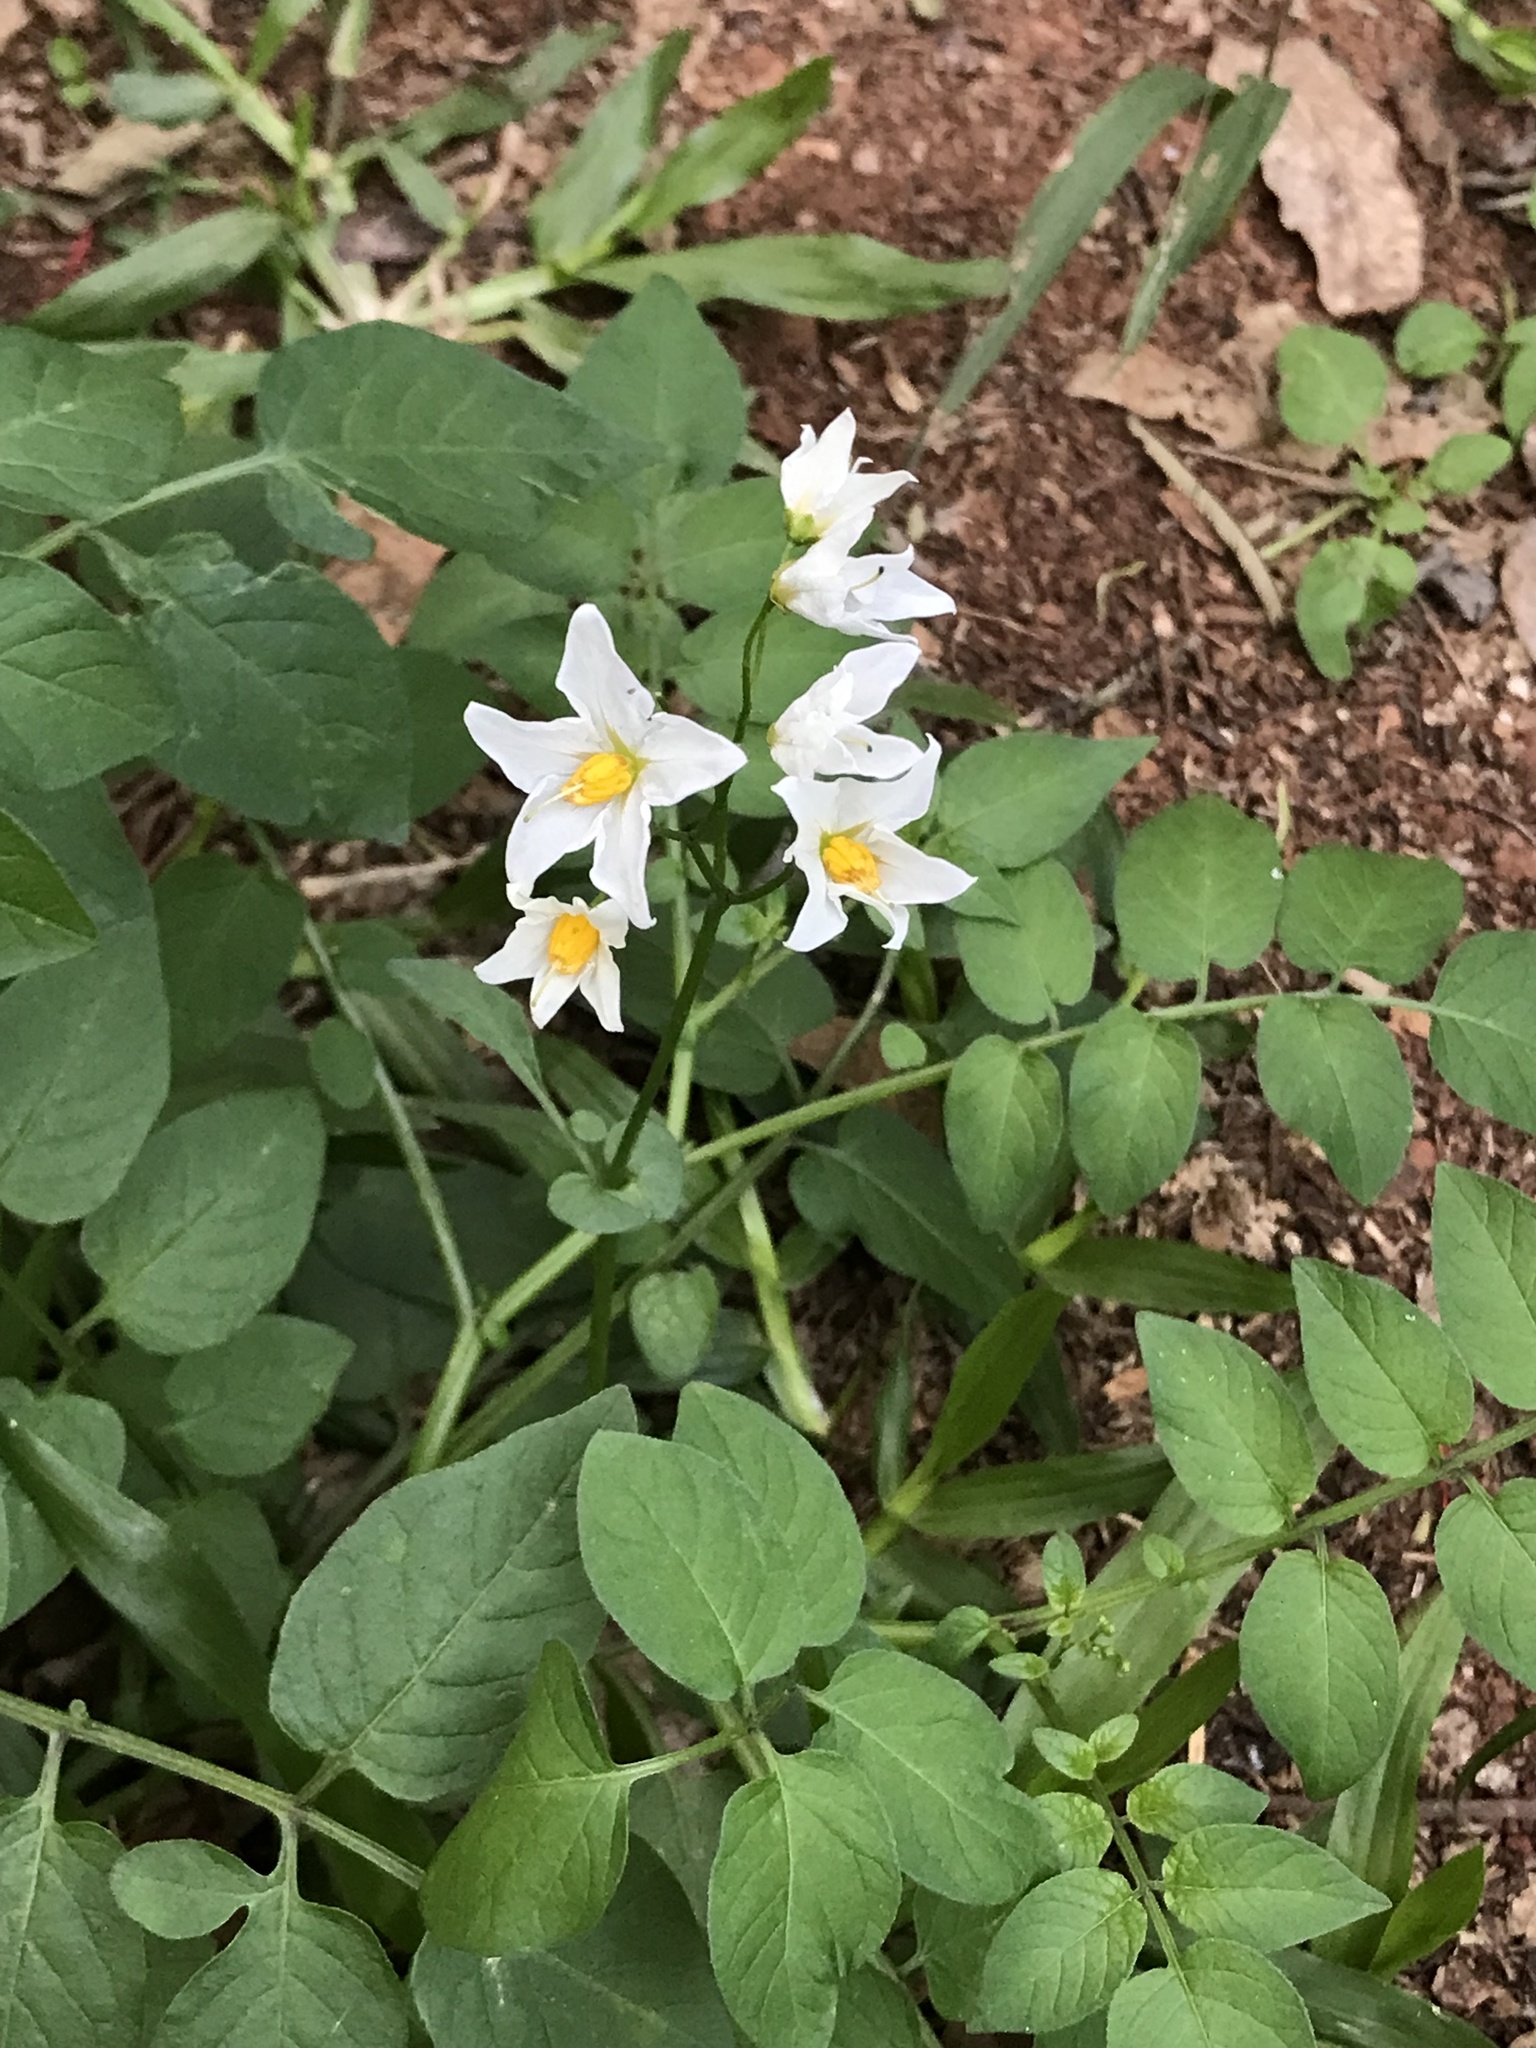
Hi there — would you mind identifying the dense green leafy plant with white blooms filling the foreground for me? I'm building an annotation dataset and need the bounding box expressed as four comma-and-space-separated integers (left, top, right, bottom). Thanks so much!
0, 279, 1536, 2048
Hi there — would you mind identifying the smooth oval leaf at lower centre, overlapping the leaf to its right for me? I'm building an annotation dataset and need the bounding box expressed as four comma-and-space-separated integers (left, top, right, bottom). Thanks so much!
578, 1436, 809, 1700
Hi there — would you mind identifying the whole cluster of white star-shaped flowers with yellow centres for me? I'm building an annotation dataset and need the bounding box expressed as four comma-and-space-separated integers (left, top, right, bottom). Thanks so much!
465, 412, 973, 1030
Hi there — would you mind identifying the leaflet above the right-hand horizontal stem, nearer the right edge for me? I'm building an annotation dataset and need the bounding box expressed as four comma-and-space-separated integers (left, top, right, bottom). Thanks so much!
1280, 846, 1466, 987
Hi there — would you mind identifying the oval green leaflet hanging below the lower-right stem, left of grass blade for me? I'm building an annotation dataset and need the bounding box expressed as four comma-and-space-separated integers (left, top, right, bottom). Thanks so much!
1239, 1550, 1399, 1800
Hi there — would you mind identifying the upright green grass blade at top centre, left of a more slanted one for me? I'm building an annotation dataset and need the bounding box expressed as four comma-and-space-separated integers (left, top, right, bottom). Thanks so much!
528, 29, 690, 270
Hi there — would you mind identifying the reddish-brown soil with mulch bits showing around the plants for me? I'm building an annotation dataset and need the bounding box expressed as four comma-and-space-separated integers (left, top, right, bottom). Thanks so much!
0, 0, 1536, 2044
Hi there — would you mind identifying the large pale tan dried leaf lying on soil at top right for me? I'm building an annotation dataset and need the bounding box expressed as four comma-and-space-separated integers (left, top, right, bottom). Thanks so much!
1208, 37, 1423, 319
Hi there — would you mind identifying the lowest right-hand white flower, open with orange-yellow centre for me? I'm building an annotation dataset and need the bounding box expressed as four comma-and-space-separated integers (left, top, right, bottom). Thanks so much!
774, 739, 975, 952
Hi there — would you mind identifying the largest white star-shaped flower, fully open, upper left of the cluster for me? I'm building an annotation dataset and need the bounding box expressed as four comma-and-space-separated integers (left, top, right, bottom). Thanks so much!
465, 604, 745, 928
